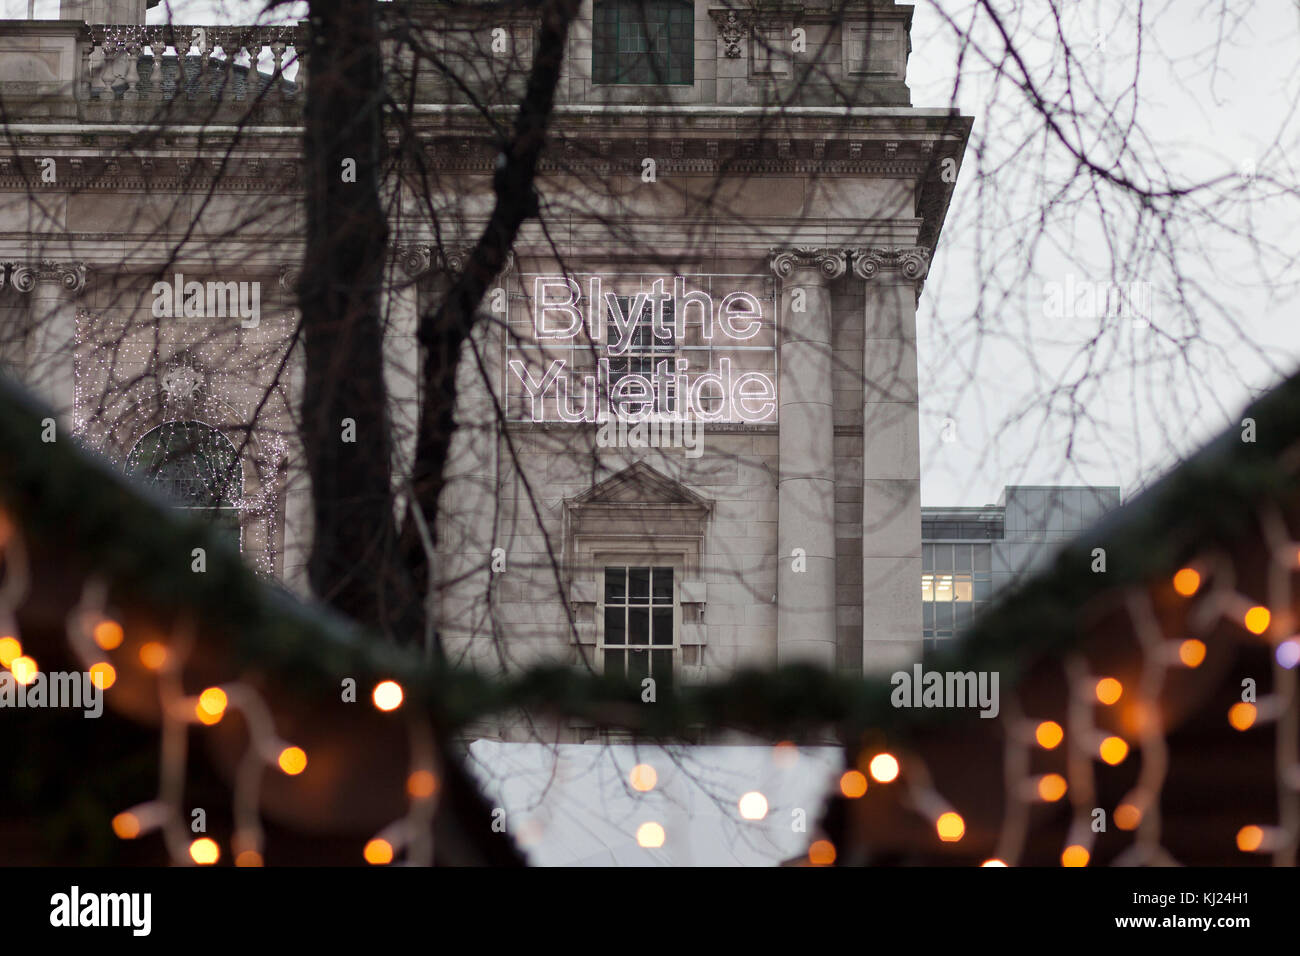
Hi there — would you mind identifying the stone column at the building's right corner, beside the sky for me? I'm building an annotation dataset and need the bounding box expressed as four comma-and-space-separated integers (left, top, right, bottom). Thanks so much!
853, 247, 930, 674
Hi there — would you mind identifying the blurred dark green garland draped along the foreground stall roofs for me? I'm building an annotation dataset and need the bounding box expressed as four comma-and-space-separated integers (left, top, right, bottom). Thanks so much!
0, 376, 1300, 739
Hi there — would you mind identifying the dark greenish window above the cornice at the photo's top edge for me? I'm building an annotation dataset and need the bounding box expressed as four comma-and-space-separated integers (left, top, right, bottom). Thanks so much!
592, 0, 696, 83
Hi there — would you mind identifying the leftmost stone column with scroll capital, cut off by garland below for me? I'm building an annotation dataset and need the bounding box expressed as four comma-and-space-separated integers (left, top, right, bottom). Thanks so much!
13, 259, 86, 431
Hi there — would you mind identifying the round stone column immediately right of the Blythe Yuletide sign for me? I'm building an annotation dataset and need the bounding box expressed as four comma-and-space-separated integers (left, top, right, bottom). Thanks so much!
772, 248, 845, 669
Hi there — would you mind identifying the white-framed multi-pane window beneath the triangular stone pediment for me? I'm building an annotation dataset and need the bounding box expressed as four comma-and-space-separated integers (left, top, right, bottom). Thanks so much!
599, 566, 677, 689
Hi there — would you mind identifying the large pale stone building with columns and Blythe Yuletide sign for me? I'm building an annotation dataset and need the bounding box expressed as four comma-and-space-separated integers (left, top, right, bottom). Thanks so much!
0, 0, 970, 712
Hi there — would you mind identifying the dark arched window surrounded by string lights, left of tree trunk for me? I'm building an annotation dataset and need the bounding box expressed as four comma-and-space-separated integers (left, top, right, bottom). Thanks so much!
126, 421, 243, 549
